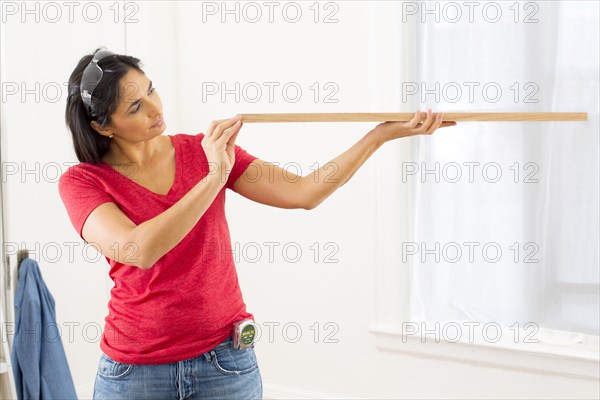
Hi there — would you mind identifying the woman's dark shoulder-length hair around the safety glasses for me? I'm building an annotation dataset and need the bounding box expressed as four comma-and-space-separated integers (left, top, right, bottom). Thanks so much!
65, 48, 144, 164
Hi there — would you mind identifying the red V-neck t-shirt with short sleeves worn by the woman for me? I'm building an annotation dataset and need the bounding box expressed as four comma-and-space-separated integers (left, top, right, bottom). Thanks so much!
58, 133, 257, 364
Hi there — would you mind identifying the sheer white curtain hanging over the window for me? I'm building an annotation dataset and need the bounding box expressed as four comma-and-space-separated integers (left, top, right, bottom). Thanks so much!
410, 1, 600, 335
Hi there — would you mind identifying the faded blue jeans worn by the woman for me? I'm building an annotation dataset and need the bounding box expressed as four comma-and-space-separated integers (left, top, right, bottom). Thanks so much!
94, 337, 263, 400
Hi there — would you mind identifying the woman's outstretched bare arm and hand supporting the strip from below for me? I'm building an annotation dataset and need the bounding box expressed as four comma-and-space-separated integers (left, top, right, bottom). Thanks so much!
234, 109, 456, 210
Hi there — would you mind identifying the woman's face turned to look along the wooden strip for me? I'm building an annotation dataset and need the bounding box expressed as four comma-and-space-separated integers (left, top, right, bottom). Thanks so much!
92, 68, 166, 142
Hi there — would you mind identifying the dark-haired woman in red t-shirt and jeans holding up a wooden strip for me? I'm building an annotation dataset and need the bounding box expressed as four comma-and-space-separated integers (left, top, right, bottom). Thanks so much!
59, 49, 455, 399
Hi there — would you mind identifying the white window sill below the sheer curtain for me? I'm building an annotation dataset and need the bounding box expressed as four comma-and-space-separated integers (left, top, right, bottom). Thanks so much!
369, 325, 600, 380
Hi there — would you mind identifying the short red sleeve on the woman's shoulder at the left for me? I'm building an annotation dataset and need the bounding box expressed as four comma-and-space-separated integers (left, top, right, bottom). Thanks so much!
58, 166, 113, 243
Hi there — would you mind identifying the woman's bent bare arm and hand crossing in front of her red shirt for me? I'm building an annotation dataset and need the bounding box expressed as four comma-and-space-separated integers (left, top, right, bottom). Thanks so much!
82, 114, 241, 269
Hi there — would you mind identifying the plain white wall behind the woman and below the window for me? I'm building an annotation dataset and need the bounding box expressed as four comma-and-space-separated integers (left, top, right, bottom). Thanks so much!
2, 1, 599, 398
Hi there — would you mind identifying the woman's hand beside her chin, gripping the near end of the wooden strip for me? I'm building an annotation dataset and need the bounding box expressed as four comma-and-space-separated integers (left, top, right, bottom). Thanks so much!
202, 114, 243, 180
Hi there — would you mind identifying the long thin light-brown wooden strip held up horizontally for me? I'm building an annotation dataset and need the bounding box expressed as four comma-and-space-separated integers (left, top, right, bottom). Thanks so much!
242, 111, 587, 123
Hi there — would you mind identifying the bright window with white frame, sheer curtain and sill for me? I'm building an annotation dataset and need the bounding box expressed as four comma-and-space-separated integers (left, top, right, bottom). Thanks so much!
372, 2, 600, 377
